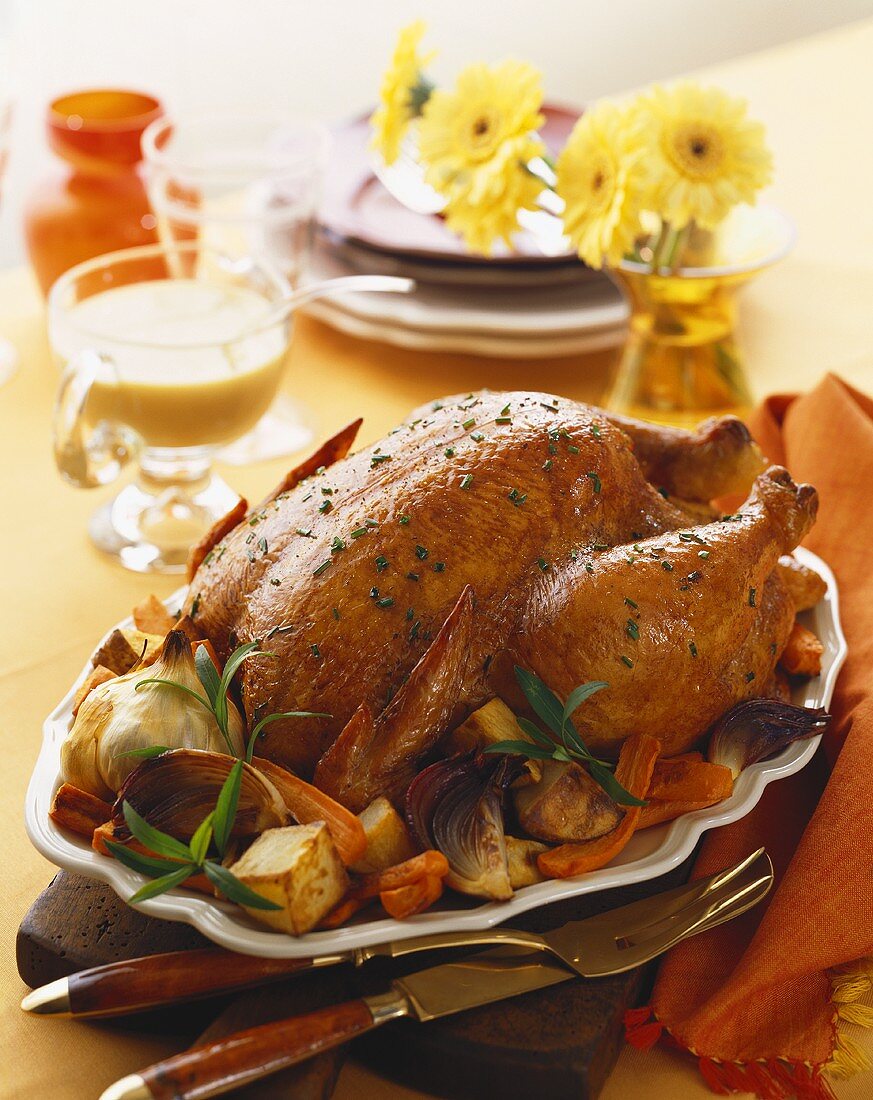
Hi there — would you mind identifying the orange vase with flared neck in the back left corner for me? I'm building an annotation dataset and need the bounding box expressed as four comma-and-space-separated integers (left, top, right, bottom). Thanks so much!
24, 89, 163, 294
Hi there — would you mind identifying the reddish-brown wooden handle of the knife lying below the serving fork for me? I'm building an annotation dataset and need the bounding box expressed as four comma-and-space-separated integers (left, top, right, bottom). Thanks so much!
139, 999, 382, 1100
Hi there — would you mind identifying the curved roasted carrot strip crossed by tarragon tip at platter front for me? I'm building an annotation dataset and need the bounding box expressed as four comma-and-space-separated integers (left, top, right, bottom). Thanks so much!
537, 734, 661, 879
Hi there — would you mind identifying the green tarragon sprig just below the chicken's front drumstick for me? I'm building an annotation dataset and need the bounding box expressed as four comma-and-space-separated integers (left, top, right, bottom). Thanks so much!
485, 664, 645, 806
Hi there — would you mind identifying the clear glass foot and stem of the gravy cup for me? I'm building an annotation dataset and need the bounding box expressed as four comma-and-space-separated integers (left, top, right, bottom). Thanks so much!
88, 451, 239, 573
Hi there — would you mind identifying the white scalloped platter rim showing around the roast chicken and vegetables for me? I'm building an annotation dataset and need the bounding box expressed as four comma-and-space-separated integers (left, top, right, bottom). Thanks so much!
24, 550, 846, 958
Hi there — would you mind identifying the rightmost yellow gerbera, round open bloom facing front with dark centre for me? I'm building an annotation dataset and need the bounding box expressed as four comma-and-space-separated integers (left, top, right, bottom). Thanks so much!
638, 81, 773, 229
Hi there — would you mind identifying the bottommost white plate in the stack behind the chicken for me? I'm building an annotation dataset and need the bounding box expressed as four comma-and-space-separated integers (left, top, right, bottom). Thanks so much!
306, 300, 626, 359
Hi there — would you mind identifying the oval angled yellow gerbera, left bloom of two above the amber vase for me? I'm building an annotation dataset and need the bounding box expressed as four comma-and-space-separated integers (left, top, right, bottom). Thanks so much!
555, 101, 644, 267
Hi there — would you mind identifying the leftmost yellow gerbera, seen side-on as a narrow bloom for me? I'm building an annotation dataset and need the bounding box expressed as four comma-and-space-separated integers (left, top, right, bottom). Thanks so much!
371, 19, 434, 164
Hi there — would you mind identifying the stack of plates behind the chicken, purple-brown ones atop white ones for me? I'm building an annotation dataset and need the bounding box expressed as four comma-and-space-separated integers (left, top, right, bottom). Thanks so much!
307, 107, 628, 359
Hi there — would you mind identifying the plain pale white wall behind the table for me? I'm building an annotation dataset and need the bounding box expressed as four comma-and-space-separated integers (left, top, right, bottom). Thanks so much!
0, 0, 873, 264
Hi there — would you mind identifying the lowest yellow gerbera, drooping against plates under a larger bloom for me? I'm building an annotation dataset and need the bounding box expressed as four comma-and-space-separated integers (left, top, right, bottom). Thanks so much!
445, 136, 544, 256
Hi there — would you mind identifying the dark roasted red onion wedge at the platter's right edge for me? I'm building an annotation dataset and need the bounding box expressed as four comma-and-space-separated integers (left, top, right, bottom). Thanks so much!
706, 699, 830, 779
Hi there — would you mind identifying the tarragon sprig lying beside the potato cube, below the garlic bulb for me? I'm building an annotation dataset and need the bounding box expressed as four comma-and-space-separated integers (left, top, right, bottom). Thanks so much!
106, 760, 281, 909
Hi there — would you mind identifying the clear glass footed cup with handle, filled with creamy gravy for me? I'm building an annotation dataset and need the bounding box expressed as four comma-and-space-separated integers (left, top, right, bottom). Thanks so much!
48, 241, 290, 573
